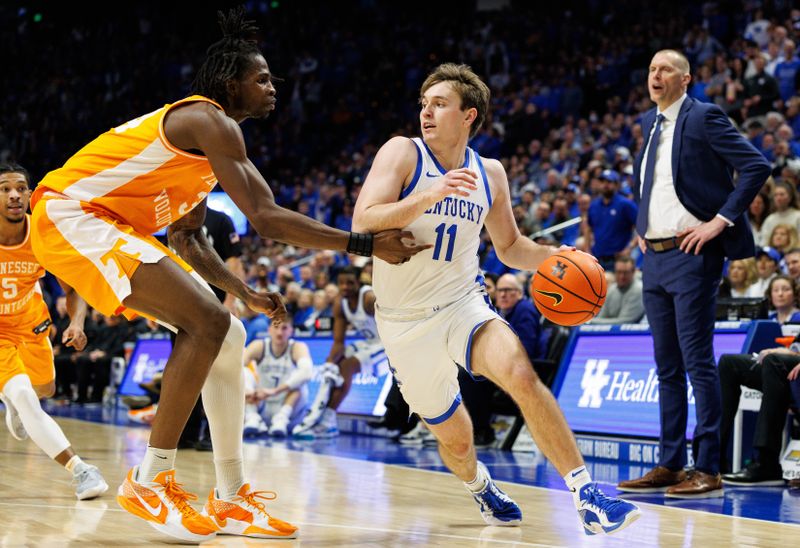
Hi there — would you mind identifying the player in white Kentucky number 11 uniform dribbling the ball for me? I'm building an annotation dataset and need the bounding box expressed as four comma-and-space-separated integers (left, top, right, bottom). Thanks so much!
353, 64, 640, 534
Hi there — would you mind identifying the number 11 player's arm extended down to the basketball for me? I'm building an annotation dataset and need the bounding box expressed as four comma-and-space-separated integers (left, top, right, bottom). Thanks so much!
483, 158, 557, 271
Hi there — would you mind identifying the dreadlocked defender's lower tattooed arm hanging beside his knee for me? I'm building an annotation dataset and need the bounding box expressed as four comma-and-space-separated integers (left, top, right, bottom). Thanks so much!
167, 200, 286, 321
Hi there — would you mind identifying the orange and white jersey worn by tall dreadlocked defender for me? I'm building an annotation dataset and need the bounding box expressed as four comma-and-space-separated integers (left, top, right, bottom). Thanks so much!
31, 95, 222, 234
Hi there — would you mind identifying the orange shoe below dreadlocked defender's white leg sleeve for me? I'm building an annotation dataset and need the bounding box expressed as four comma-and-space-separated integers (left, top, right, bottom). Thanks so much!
203, 483, 297, 539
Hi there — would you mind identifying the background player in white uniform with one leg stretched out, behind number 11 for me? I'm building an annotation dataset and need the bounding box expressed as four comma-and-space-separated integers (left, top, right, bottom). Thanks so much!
292, 266, 385, 439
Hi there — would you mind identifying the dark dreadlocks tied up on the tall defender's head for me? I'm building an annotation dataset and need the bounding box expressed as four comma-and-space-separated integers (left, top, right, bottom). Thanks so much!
192, 6, 261, 106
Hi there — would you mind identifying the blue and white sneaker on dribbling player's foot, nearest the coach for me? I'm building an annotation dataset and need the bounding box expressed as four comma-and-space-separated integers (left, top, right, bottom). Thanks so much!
572, 483, 642, 535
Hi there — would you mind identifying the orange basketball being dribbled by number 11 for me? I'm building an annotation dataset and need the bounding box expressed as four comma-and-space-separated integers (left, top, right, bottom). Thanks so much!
530, 251, 606, 326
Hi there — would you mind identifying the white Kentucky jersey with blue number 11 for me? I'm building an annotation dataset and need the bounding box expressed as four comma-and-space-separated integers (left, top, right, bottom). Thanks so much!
373, 138, 492, 309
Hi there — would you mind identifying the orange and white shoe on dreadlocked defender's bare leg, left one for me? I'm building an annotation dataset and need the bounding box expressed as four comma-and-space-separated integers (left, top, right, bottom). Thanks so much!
117, 466, 218, 542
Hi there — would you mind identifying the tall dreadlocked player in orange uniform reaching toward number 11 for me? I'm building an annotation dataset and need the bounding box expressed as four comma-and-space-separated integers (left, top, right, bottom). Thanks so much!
32, 8, 424, 542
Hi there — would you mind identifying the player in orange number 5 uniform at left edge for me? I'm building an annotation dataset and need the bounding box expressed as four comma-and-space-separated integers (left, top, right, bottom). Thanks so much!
0, 164, 108, 500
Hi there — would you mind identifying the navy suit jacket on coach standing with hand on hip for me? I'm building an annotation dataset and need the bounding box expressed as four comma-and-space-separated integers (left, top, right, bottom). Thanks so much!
633, 97, 771, 259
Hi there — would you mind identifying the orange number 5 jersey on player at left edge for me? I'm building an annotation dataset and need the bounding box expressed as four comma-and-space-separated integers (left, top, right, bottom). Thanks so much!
0, 215, 46, 330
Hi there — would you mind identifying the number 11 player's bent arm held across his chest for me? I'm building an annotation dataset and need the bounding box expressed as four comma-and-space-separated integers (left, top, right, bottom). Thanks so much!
353, 137, 477, 232
